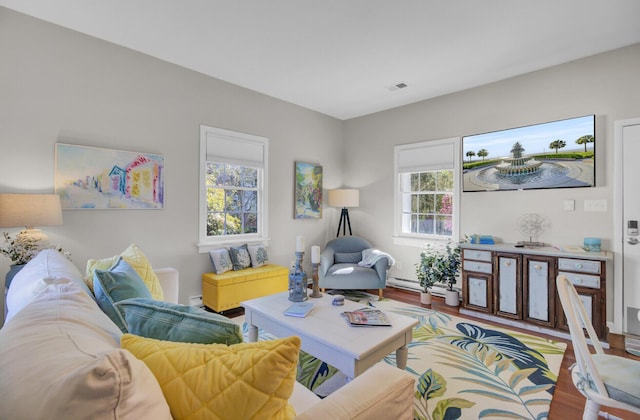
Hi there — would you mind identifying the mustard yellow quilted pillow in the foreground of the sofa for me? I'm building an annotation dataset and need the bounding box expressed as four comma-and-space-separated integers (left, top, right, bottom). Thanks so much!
120, 334, 300, 419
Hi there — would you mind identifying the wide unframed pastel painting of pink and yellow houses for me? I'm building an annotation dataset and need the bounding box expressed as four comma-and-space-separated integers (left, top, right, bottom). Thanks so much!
55, 143, 164, 209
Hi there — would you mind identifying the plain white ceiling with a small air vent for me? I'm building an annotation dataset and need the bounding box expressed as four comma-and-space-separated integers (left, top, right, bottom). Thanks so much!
0, 0, 640, 120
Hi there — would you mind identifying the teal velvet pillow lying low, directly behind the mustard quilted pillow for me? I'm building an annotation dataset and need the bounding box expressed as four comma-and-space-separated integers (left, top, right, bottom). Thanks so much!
116, 298, 242, 345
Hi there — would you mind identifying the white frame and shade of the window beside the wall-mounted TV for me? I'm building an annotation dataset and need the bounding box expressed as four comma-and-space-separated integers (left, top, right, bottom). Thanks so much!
393, 137, 462, 247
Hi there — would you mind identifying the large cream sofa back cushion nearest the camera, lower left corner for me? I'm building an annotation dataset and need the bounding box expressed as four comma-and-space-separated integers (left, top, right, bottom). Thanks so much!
0, 278, 171, 419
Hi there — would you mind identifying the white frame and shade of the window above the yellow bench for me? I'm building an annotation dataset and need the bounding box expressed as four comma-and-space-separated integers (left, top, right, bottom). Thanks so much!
198, 125, 269, 253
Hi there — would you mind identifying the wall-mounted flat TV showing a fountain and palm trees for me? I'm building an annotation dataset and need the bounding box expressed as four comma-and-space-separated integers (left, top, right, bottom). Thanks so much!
462, 115, 595, 192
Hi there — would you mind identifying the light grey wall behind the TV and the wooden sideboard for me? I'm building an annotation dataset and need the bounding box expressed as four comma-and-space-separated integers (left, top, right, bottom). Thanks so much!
344, 44, 640, 324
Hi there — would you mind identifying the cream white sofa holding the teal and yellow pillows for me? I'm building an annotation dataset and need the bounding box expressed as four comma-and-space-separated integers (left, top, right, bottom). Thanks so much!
0, 250, 414, 420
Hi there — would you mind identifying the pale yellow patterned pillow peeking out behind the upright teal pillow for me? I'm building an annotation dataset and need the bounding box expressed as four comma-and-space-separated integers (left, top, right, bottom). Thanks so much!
85, 244, 164, 300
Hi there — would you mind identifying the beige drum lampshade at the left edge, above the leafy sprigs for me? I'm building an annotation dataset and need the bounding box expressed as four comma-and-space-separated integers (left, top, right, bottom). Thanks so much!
0, 194, 62, 227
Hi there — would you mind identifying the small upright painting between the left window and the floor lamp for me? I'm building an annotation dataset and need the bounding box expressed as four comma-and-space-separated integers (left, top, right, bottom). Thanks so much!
294, 162, 322, 219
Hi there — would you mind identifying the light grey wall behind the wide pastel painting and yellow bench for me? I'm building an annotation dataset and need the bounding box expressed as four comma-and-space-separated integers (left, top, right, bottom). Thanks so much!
0, 7, 343, 320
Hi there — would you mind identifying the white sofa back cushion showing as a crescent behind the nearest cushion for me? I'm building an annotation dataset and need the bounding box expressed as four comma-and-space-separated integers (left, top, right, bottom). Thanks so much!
5, 249, 91, 324
